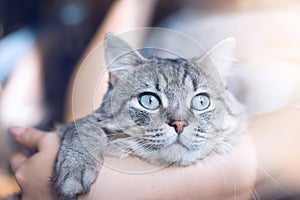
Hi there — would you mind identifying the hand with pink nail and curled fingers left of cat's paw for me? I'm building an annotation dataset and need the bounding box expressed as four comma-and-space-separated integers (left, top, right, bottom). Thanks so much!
10, 127, 60, 200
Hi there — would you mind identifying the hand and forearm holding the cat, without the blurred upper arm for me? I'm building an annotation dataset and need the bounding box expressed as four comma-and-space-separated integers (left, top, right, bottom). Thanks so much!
11, 128, 255, 200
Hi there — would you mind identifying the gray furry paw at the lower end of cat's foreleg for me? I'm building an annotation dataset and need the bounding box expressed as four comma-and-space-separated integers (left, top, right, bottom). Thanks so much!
52, 152, 100, 199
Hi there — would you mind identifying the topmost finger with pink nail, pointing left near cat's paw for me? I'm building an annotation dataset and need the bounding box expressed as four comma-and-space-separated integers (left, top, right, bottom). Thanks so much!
10, 126, 46, 150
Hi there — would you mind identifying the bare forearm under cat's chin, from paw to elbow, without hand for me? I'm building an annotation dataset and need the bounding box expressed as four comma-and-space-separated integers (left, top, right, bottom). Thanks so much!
81, 135, 256, 200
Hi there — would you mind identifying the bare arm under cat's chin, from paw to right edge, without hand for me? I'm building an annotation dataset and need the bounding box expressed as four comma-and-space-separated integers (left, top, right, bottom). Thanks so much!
82, 108, 300, 199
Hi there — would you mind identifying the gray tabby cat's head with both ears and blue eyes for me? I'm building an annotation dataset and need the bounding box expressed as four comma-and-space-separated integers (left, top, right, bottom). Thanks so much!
99, 34, 246, 165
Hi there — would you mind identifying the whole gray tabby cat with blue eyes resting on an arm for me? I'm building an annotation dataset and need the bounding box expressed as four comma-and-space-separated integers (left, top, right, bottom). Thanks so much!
53, 34, 247, 199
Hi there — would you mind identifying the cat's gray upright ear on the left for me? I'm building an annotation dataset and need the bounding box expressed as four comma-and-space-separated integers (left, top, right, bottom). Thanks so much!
104, 33, 145, 84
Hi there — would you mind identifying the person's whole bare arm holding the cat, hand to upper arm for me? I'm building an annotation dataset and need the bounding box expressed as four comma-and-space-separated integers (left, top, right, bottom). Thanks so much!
11, 109, 300, 200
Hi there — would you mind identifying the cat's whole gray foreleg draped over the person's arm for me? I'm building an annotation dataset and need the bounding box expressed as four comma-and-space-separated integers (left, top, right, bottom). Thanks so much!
52, 115, 107, 199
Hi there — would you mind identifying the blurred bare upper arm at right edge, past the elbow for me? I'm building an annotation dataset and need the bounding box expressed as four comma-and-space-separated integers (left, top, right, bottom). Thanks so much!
250, 108, 300, 195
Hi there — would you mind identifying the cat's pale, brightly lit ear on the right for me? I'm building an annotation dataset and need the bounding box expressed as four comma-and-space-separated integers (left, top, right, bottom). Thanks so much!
197, 37, 236, 85
